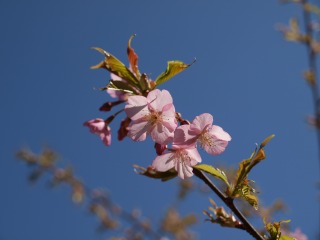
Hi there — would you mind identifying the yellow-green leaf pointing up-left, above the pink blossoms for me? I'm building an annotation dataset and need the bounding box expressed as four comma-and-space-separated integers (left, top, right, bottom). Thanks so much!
91, 48, 139, 87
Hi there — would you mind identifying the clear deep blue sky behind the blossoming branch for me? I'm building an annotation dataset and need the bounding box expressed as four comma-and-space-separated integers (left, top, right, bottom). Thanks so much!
0, 0, 319, 240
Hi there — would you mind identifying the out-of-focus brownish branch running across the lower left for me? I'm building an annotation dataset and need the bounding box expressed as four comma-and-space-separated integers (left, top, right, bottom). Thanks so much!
17, 149, 197, 240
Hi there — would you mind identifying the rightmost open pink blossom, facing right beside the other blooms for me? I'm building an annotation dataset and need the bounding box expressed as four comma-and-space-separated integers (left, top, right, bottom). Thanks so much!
176, 113, 231, 155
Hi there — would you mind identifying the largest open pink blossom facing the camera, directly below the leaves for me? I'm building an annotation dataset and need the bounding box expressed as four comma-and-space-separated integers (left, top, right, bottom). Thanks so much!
125, 89, 177, 145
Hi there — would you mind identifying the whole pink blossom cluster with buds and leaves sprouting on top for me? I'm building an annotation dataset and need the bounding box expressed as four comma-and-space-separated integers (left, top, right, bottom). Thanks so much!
84, 37, 231, 179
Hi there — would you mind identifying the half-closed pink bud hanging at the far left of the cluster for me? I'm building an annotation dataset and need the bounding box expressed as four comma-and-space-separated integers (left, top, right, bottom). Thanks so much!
83, 118, 111, 146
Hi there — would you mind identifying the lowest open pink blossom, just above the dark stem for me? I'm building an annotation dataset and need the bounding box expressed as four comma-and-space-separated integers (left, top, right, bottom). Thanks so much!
152, 125, 201, 179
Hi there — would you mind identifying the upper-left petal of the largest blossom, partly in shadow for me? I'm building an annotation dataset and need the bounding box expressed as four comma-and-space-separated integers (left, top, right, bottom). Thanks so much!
124, 96, 150, 121
